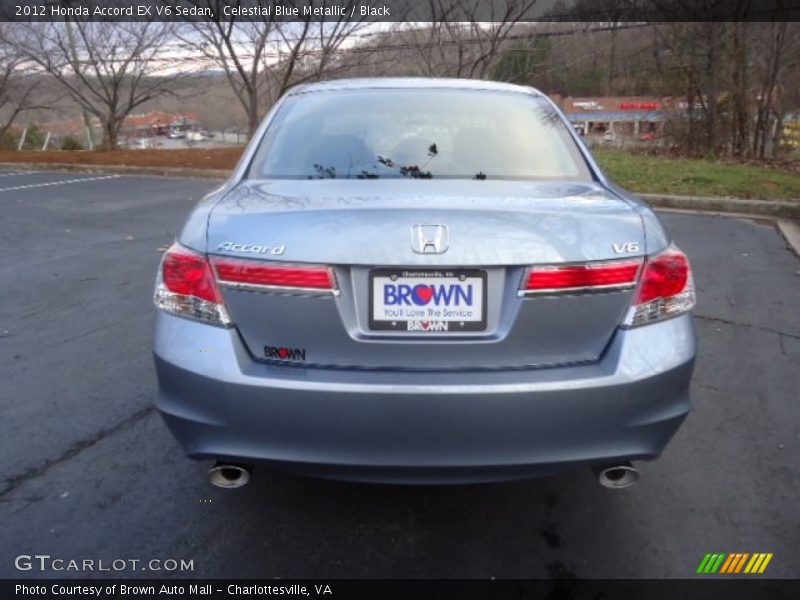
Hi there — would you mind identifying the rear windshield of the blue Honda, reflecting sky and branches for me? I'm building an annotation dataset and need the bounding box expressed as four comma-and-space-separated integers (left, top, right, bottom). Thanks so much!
249, 89, 591, 181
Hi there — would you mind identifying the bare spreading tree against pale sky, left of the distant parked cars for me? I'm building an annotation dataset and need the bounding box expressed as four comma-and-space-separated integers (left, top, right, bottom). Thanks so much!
6, 21, 178, 149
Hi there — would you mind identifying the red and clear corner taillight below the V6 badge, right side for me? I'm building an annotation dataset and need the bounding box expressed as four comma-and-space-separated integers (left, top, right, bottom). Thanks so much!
625, 245, 695, 327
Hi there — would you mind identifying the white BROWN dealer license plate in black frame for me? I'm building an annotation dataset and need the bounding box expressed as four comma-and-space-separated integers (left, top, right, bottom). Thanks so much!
369, 269, 486, 333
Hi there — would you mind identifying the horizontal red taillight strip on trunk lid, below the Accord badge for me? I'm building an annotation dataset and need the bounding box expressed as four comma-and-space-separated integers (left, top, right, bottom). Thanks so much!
212, 256, 337, 294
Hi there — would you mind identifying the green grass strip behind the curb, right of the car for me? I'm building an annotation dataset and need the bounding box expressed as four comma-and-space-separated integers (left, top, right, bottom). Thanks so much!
593, 150, 800, 200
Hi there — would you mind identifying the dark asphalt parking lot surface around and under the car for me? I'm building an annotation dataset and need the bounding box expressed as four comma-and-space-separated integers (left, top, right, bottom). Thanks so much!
0, 166, 800, 578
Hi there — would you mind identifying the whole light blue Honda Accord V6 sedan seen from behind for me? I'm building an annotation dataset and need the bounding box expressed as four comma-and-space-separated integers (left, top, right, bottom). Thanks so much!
155, 79, 695, 487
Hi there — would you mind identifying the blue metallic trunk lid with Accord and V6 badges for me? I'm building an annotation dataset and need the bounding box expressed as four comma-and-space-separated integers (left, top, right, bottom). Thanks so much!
208, 180, 644, 370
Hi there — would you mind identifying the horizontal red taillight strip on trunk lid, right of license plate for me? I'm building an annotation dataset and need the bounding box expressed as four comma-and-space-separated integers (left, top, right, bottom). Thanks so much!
520, 260, 642, 296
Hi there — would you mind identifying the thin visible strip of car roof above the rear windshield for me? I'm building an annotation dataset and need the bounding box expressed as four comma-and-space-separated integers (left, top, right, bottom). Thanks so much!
289, 77, 542, 96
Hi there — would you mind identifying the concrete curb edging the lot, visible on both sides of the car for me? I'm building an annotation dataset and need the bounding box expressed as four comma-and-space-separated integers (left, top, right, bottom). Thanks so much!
0, 162, 800, 221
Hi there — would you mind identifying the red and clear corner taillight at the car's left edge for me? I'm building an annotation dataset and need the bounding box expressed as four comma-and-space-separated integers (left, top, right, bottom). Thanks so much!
153, 243, 231, 325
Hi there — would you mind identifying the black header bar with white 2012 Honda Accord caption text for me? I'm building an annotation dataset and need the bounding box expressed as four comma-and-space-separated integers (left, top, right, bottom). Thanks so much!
0, 0, 800, 23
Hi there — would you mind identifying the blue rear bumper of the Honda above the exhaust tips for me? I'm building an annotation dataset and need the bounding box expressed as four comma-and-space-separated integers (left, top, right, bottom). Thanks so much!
155, 313, 696, 483
